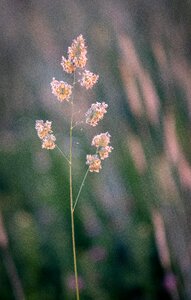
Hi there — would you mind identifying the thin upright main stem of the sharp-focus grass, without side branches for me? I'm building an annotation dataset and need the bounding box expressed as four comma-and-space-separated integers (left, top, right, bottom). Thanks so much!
69, 72, 80, 300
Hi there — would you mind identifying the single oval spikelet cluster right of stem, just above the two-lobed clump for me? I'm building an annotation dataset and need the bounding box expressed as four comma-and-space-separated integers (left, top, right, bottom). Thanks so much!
85, 102, 108, 127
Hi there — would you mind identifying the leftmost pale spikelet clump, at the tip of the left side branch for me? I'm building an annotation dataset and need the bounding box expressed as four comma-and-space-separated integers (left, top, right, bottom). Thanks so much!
35, 120, 56, 150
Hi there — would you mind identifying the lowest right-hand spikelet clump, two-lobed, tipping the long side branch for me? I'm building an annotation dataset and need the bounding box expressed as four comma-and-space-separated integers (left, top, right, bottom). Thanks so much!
86, 132, 113, 173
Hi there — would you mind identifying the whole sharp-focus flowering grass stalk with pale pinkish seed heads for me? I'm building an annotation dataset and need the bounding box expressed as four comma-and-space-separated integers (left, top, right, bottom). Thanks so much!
35, 35, 113, 300
